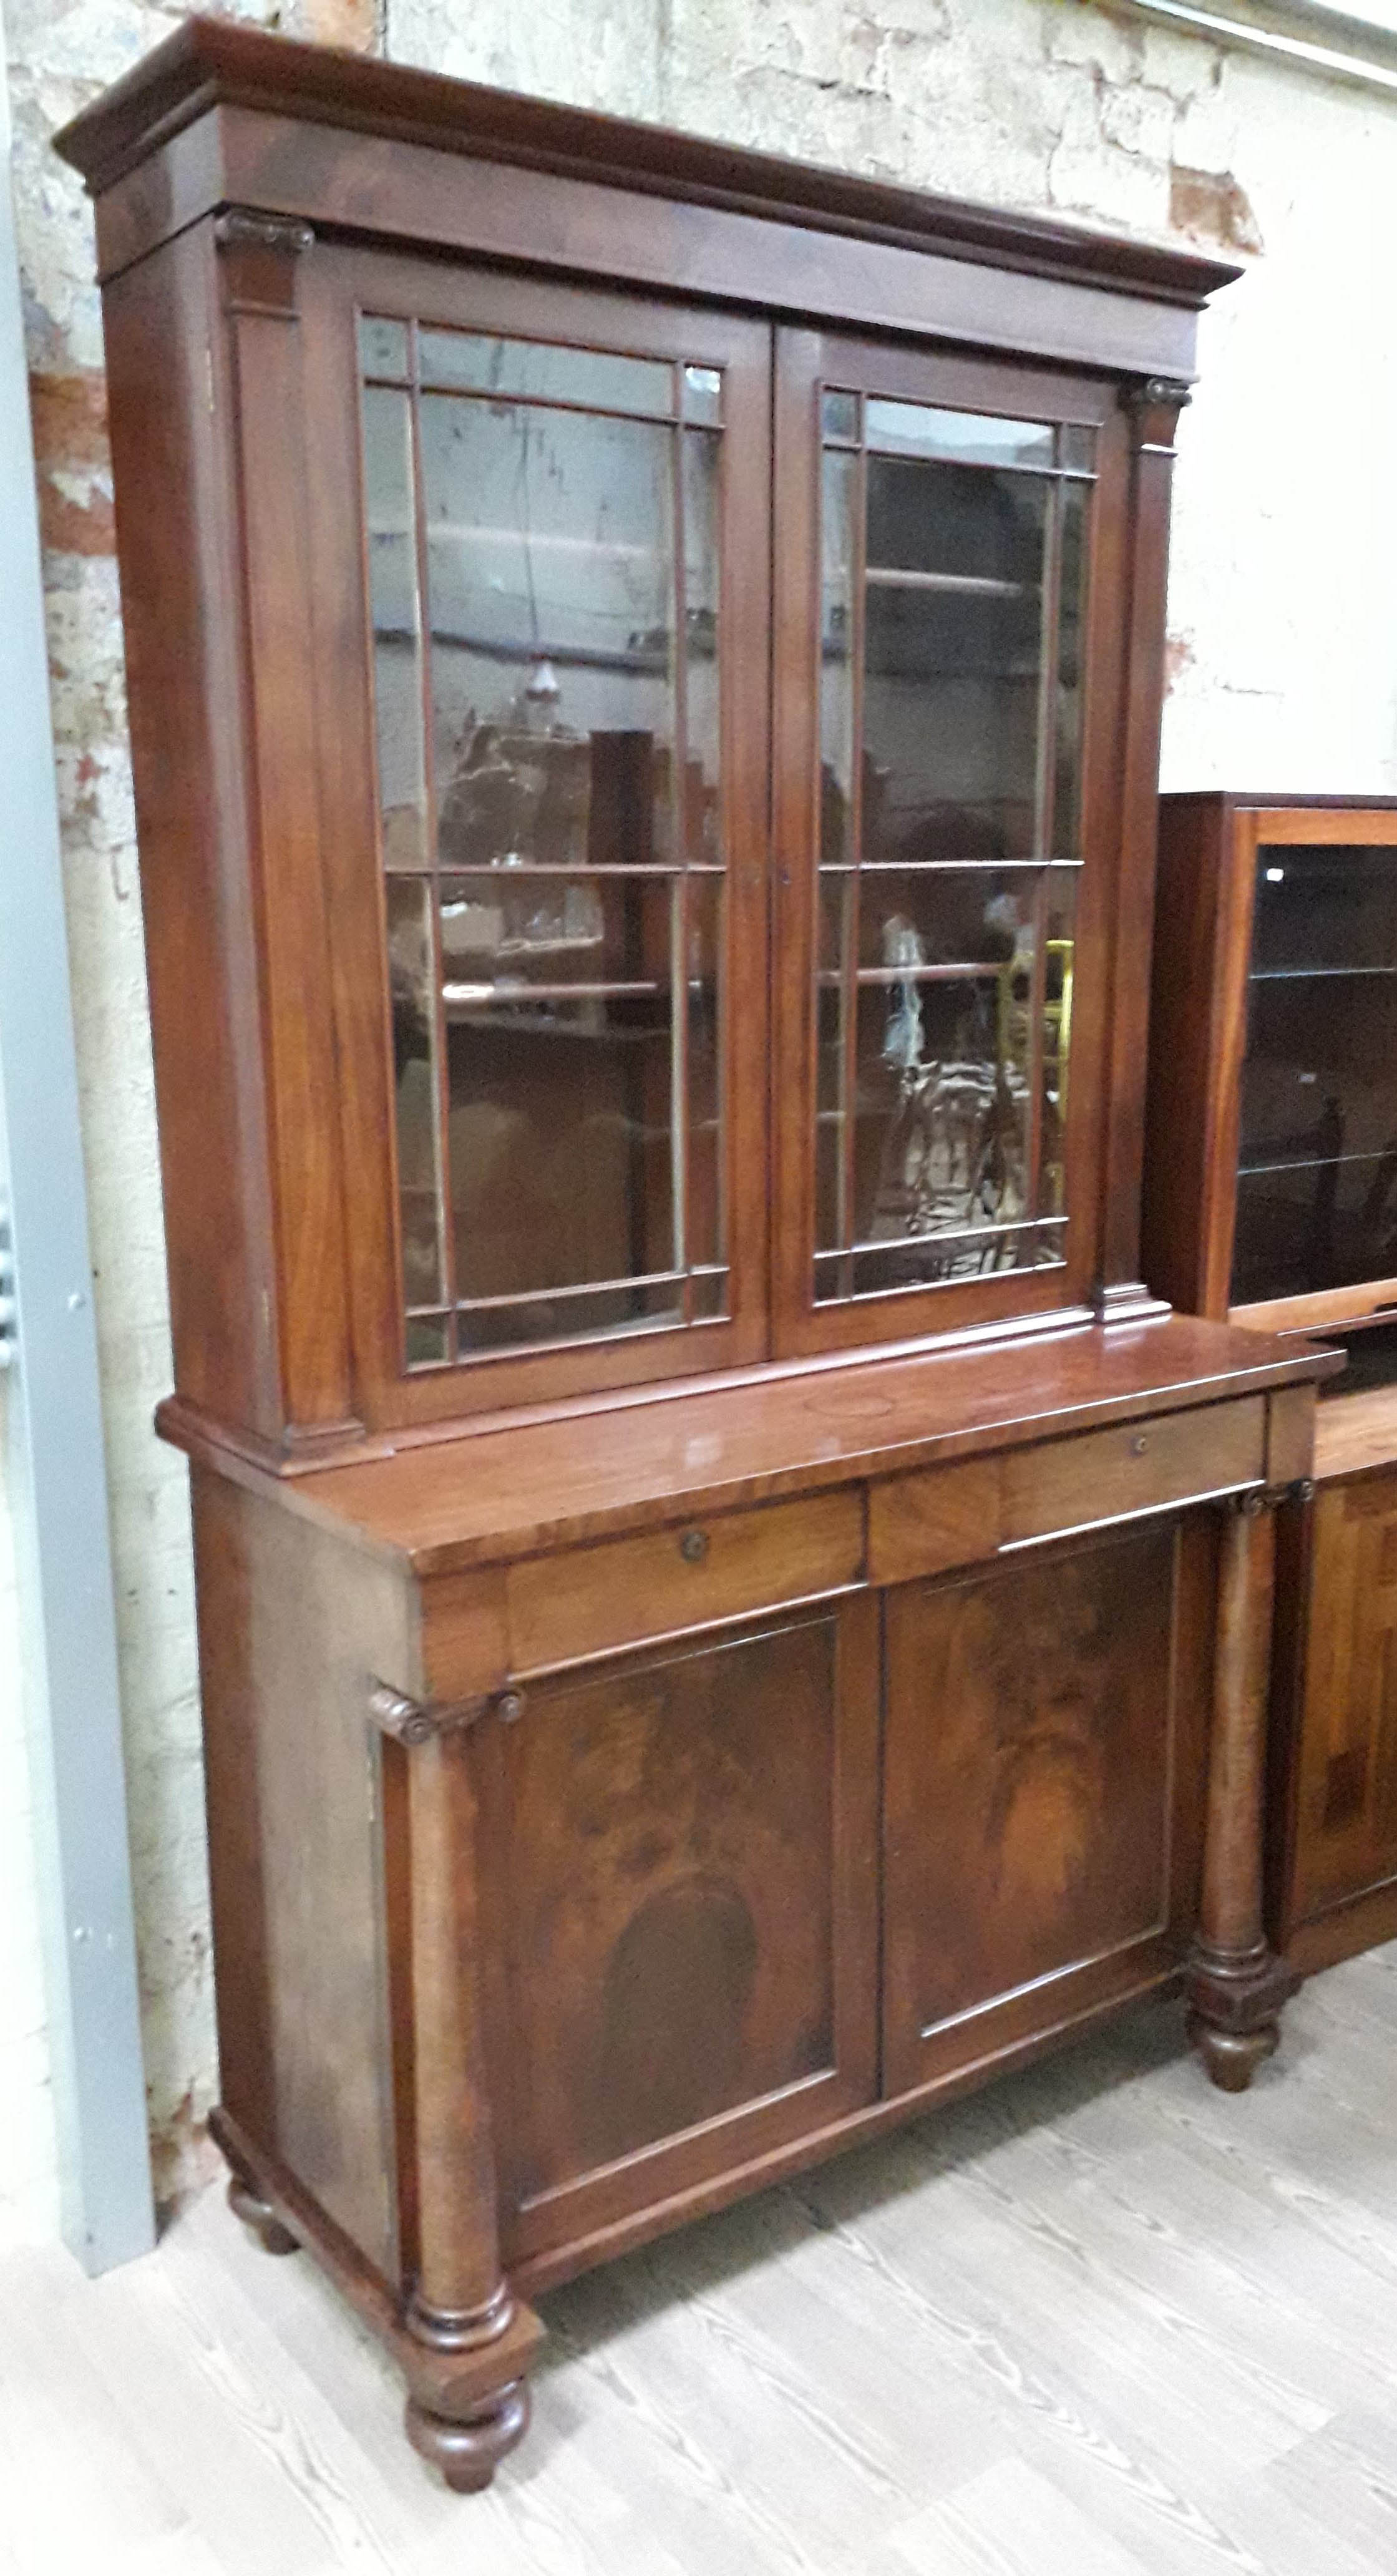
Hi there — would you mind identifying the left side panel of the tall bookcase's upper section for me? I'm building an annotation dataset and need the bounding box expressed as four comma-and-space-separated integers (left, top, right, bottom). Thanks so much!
103, 232, 278, 1432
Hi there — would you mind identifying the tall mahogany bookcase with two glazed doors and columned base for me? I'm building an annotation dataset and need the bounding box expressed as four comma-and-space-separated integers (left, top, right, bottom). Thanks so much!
59, 23, 1333, 2489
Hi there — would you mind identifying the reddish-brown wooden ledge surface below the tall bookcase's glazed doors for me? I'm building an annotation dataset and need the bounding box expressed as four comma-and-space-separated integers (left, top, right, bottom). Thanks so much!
203, 1316, 1343, 1574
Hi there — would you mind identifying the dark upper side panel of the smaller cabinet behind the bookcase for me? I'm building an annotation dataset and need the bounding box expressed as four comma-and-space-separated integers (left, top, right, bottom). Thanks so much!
1142, 796, 1222, 1314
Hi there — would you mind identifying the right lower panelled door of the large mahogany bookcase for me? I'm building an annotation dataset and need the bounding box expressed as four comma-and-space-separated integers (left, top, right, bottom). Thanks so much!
884, 1515, 1214, 2094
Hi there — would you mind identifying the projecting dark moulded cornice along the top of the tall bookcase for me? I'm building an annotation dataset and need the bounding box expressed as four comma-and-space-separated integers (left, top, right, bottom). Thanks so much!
54, 18, 1242, 309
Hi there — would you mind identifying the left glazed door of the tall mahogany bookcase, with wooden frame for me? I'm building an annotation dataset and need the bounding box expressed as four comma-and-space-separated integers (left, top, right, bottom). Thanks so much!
301, 247, 771, 1425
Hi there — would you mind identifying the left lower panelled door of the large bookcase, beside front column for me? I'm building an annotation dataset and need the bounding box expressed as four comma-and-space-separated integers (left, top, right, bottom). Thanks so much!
477, 1594, 879, 2265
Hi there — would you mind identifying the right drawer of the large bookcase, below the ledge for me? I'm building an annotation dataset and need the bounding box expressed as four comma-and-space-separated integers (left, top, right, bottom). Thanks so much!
1000, 1396, 1265, 1546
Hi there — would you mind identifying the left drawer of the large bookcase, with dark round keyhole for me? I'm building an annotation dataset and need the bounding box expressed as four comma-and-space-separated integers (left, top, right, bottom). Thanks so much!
505, 1489, 864, 1672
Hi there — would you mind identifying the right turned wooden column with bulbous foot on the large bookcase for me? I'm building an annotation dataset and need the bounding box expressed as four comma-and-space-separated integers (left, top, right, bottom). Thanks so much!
1188, 1486, 1297, 2092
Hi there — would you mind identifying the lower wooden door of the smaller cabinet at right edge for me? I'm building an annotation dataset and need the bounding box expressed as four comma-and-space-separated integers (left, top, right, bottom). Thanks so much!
1286, 1473, 1397, 1921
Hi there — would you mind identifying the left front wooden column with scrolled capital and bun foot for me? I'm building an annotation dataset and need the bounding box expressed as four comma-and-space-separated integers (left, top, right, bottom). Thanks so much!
371, 1687, 542, 2494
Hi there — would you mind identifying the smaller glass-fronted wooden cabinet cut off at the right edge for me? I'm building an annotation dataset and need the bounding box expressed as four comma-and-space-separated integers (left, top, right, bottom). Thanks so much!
1144, 796, 1397, 1971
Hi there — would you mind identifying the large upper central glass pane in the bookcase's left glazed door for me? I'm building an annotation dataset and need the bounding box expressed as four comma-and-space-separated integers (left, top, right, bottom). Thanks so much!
422, 394, 675, 866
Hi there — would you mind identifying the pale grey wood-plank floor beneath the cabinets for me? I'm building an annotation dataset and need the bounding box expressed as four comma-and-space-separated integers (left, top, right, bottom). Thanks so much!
0, 1943, 1397, 2576
